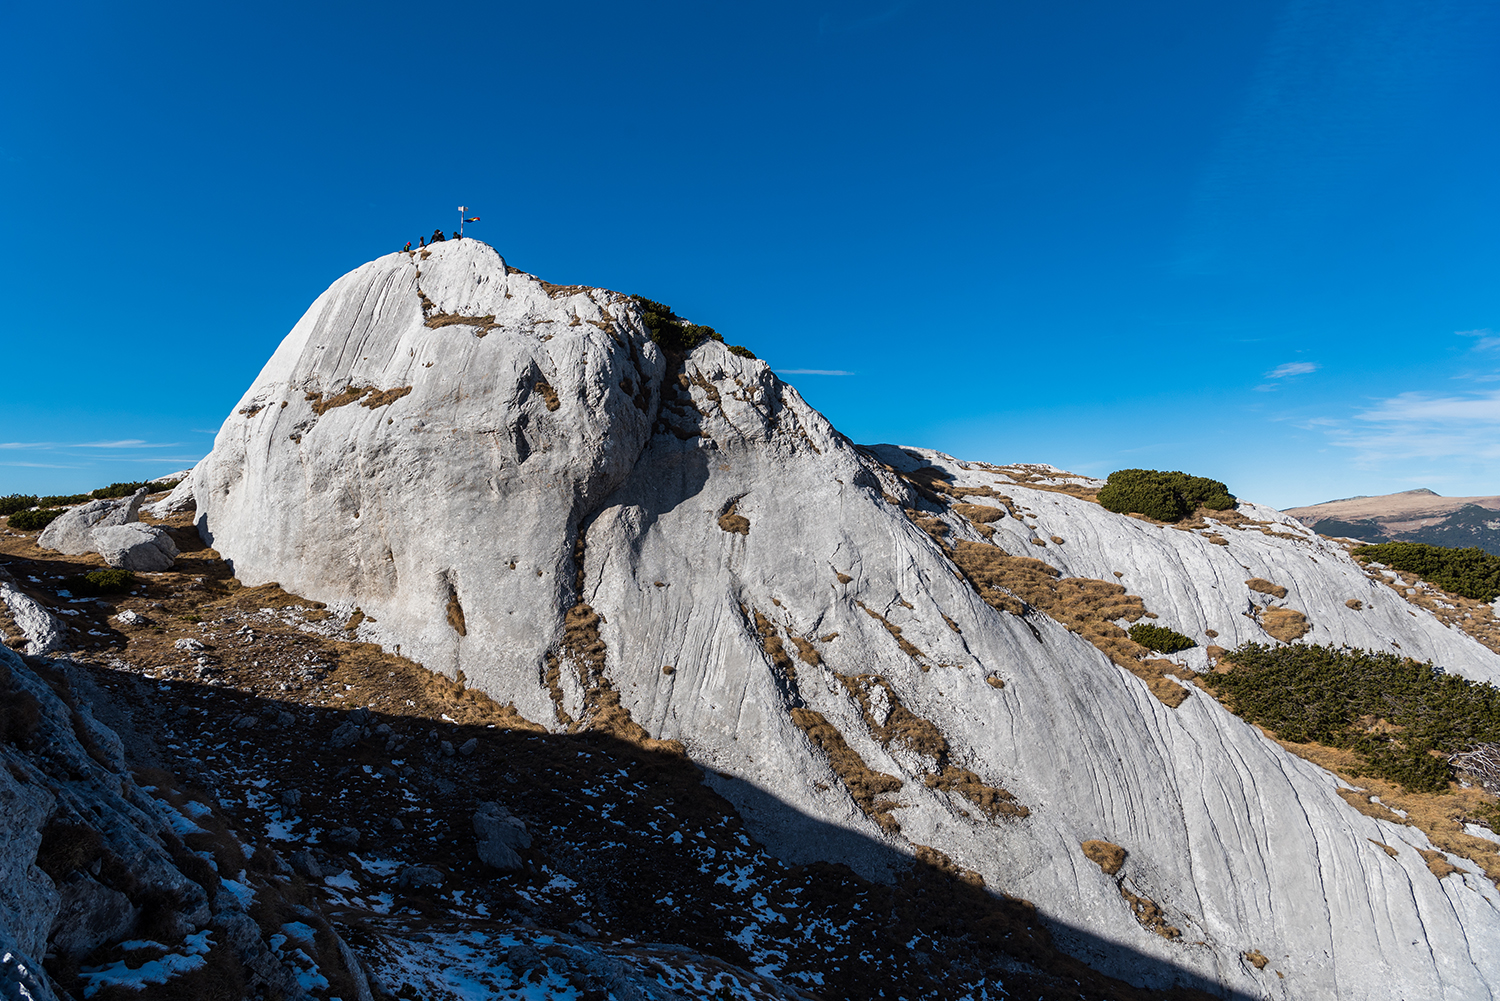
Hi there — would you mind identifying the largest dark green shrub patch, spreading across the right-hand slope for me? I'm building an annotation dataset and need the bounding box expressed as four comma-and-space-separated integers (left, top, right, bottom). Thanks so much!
1202, 644, 1500, 792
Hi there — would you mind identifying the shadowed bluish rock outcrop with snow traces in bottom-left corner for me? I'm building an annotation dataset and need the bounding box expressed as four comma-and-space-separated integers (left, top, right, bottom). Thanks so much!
0, 647, 354, 1001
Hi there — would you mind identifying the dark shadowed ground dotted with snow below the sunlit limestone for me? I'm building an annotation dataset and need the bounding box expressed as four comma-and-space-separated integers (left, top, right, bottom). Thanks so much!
76, 657, 1271, 999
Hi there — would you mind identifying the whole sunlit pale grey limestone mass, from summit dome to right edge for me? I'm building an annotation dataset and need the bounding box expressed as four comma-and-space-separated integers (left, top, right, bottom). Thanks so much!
194, 240, 1500, 998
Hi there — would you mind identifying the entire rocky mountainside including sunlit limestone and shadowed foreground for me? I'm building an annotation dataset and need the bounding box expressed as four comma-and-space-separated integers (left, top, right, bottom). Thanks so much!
0, 240, 1500, 1001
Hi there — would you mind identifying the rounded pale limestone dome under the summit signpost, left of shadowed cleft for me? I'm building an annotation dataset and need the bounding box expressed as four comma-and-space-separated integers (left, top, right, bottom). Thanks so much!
192, 240, 665, 714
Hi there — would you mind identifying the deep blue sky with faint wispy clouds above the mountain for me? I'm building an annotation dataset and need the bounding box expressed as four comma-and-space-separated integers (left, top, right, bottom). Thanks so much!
0, 0, 1500, 507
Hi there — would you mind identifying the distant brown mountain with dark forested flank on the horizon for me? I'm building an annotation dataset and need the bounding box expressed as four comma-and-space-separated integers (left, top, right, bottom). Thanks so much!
1284, 488, 1500, 555
